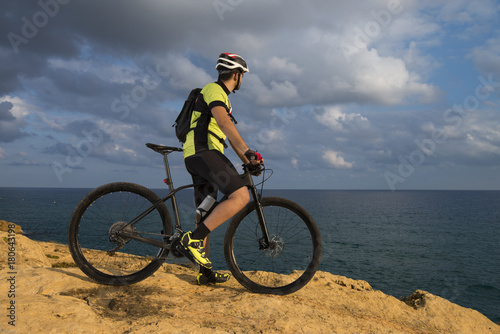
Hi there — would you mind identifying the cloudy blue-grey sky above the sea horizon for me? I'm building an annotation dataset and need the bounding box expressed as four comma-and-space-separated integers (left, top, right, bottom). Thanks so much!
0, 0, 500, 190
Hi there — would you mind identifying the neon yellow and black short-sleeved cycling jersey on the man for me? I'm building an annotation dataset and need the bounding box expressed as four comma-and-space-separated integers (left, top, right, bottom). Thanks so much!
182, 82, 231, 158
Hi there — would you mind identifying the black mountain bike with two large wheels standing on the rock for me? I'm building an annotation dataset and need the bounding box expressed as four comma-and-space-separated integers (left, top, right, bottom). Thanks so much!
68, 143, 322, 295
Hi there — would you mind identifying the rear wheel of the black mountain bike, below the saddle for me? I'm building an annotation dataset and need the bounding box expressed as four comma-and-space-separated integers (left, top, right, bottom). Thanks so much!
68, 182, 172, 285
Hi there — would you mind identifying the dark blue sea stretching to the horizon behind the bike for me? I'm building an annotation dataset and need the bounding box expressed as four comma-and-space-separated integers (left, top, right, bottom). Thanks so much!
0, 188, 500, 323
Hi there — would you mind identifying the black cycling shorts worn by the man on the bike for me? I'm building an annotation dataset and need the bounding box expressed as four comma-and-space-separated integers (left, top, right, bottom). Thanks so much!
184, 150, 245, 206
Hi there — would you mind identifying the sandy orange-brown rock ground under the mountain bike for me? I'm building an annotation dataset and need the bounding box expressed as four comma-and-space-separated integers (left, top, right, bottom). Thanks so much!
0, 232, 500, 333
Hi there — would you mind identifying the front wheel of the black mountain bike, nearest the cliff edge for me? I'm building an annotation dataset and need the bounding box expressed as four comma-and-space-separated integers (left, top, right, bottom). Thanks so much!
224, 197, 322, 295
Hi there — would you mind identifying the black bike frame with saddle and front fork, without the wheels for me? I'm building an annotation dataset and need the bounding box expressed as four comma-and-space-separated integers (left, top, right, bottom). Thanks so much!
116, 144, 270, 250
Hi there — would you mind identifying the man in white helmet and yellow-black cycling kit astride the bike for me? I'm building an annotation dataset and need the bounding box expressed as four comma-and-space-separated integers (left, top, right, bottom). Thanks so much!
180, 53, 263, 285
